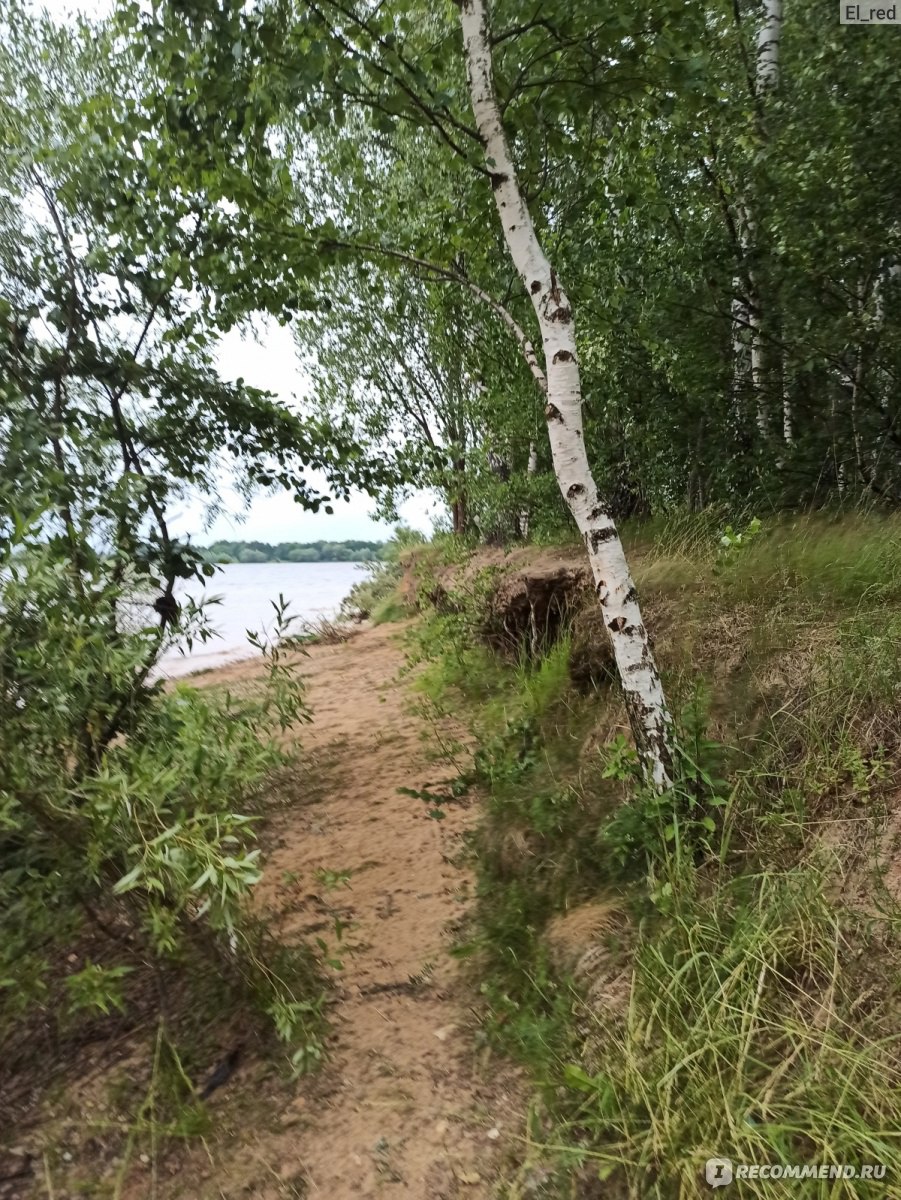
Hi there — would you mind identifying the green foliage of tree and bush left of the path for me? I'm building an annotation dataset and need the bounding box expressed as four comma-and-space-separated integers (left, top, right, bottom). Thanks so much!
0, 5, 355, 1089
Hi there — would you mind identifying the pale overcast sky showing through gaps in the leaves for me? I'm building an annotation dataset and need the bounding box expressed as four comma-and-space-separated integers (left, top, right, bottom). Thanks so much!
32, 0, 439, 542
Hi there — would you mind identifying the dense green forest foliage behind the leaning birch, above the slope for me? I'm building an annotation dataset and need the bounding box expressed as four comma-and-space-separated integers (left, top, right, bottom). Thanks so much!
107, 0, 901, 534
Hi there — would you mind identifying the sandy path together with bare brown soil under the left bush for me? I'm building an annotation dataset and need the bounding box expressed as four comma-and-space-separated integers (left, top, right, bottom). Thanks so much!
0, 625, 525, 1200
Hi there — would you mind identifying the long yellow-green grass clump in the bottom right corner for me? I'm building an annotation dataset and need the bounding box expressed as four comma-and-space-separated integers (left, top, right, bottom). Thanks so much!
561, 868, 901, 1200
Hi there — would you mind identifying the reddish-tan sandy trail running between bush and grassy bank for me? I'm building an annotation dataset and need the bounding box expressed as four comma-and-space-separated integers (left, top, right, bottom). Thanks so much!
205, 626, 522, 1200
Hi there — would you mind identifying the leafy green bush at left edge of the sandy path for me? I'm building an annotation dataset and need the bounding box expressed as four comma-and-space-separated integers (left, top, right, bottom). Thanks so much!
0, 533, 319, 1063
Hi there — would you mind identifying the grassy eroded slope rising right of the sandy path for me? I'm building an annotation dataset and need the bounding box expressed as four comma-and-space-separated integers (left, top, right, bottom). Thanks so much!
405, 516, 901, 1198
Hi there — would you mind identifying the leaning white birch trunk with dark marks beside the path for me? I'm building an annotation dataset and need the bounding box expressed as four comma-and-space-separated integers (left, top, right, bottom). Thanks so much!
461, 0, 672, 790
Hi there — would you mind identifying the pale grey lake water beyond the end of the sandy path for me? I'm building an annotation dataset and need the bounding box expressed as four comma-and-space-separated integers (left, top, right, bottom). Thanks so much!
160, 563, 364, 676
